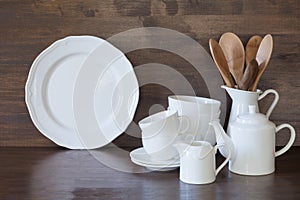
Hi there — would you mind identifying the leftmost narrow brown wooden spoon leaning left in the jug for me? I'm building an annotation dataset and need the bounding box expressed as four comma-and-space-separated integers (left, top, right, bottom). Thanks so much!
209, 39, 234, 87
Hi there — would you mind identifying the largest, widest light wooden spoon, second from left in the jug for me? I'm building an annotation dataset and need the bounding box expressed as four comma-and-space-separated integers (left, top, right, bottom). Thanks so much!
219, 32, 245, 85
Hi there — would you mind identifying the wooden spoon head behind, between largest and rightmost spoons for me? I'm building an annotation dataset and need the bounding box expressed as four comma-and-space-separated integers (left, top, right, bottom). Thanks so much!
246, 35, 262, 66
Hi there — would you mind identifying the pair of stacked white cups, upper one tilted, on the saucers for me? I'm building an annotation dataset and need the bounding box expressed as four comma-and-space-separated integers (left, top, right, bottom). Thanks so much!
139, 110, 189, 160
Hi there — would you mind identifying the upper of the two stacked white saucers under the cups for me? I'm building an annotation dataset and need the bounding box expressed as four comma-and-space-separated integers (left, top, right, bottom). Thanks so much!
129, 147, 180, 167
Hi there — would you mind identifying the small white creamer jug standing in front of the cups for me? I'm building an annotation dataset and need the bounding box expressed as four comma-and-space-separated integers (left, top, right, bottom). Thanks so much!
174, 141, 230, 184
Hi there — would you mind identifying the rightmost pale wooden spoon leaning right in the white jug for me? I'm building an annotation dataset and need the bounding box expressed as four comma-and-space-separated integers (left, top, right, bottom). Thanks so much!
250, 34, 273, 91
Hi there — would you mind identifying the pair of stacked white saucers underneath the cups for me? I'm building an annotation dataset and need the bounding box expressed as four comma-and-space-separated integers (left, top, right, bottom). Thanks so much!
129, 147, 180, 171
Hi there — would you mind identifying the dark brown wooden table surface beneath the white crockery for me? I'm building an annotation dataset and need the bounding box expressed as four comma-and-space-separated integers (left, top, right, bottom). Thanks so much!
0, 147, 300, 199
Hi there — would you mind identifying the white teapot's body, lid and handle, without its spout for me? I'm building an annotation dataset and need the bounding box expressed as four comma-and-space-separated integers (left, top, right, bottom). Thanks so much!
229, 106, 296, 175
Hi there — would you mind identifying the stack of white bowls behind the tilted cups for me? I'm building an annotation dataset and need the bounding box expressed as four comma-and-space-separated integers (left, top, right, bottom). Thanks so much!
168, 95, 221, 145
